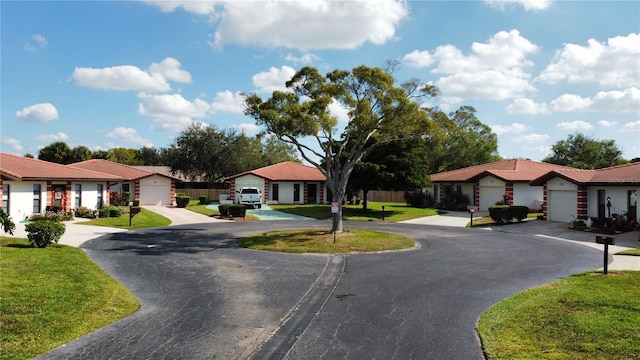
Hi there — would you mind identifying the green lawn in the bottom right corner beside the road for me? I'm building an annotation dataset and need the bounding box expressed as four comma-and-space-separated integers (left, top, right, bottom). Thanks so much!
478, 271, 640, 359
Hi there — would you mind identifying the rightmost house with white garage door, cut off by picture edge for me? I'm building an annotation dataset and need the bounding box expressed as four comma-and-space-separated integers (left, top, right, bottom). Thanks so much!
531, 162, 640, 222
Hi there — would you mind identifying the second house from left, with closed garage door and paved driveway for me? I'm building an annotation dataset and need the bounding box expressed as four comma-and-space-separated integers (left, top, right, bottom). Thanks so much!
69, 159, 180, 205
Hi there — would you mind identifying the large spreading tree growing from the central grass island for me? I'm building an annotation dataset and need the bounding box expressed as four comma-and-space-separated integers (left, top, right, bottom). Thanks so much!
245, 66, 429, 232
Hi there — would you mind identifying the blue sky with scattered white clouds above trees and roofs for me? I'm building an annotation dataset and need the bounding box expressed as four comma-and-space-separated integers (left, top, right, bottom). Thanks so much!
0, 0, 640, 161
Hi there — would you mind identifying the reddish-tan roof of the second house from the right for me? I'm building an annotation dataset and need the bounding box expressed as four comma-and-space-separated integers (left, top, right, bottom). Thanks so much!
430, 159, 571, 182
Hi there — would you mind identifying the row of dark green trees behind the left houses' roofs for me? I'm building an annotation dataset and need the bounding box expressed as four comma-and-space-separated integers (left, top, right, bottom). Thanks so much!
30, 128, 300, 183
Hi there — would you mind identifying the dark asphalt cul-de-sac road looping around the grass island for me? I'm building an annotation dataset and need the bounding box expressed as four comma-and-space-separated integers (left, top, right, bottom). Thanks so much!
40, 221, 602, 359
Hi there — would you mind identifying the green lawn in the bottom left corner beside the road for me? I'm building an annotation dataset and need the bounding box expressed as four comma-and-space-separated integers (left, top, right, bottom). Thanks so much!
0, 237, 139, 359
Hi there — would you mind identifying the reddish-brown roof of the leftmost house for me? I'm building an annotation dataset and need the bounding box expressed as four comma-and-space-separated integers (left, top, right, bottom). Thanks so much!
0, 153, 121, 181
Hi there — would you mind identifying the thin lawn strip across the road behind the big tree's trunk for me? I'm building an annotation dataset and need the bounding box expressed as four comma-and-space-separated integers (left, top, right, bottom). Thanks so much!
271, 202, 441, 222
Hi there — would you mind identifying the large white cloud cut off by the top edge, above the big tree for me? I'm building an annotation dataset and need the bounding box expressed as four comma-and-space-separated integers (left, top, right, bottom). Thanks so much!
145, 0, 409, 49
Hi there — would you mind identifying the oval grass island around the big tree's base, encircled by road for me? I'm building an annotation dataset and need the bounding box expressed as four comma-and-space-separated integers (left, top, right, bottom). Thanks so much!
238, 229, 415, 254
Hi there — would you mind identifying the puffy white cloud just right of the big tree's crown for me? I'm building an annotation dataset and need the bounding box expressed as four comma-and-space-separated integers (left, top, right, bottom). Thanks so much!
424, 30, 539, 102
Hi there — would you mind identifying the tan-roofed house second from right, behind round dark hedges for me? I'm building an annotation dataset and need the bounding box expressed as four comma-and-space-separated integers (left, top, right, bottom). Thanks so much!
428, 159, 570, 211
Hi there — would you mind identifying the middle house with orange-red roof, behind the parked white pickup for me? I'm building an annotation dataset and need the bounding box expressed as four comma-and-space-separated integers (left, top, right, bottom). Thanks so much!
227, 161, 327, 204
